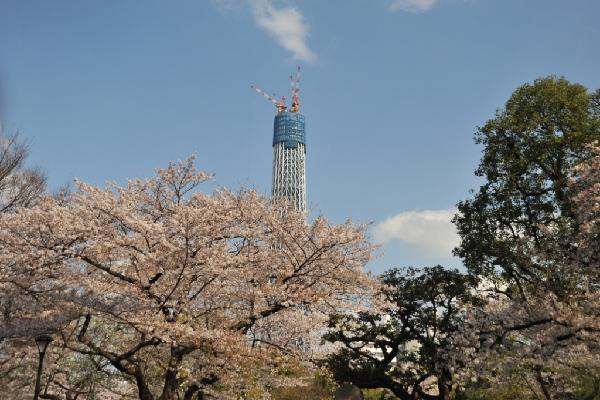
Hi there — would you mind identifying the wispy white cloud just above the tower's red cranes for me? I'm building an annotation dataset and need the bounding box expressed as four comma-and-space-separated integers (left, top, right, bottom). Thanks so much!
250, 0, 316, 62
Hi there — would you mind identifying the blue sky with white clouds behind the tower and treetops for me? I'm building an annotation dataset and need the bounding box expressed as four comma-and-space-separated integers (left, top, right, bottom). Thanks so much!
0, 0, 600, 272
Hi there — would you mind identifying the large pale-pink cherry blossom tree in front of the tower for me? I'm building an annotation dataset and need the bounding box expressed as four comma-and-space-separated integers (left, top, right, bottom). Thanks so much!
0, 158, 375, 400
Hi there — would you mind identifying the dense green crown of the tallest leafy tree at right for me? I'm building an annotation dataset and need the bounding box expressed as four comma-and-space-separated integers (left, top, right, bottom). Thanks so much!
454, 76, 600, 296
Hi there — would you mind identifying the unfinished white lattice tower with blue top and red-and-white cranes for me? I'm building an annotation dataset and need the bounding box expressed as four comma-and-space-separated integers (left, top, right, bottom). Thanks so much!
252, 67, 306, 213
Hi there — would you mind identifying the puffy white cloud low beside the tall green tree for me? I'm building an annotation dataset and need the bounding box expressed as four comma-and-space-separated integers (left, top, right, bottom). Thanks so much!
373, 209, 459, 258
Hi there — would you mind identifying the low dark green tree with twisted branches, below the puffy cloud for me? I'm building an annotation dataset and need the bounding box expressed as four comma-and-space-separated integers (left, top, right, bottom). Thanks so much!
325, 266, 475, 399
